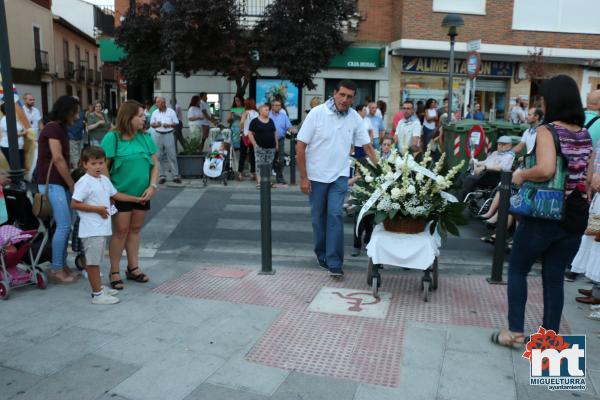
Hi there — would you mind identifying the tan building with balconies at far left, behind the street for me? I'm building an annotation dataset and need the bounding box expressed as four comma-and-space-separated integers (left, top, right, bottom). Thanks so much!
54, 16, 103, 107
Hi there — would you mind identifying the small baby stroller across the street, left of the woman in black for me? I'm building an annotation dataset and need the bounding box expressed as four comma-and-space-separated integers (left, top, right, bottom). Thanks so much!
202, 128, 233, 186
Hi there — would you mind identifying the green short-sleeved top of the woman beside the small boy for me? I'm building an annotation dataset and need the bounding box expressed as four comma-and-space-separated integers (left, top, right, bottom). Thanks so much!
102, 131, 156, 196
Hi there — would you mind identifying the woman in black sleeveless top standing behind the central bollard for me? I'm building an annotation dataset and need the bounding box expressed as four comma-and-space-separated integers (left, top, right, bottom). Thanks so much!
248, 104, 278, 188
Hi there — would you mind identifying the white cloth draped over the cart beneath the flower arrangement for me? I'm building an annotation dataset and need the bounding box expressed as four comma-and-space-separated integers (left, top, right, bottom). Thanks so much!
367, 224, 441, 270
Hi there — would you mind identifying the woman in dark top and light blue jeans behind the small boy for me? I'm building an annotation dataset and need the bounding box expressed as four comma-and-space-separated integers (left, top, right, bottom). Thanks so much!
37, 96, 79, 283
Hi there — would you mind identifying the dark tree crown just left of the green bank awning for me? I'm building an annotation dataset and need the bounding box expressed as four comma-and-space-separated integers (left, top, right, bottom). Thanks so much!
256, 0, 357, 90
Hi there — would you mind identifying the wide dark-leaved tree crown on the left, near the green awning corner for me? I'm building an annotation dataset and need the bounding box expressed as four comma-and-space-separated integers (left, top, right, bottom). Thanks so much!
115, 0, 240, 82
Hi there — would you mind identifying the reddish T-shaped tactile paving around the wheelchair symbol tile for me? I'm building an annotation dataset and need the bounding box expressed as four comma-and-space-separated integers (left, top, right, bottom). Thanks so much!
155, 267, 569, 387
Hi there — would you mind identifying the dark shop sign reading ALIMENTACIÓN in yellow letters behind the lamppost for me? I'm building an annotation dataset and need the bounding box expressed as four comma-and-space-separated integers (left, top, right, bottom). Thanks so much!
402, 57, 514, 78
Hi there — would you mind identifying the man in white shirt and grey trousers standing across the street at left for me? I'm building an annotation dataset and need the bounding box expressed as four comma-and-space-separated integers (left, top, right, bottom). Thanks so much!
150, 96, 181, 184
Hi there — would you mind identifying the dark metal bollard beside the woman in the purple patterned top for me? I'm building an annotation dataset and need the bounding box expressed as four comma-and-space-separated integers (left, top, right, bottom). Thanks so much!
487, 171, 512, 285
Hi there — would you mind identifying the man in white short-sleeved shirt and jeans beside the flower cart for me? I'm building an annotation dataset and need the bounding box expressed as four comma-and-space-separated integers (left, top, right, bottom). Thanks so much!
296, 80, 377, 276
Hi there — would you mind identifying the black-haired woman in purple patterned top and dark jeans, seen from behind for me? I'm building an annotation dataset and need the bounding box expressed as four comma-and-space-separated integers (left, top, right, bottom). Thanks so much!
492, 75, 592, 347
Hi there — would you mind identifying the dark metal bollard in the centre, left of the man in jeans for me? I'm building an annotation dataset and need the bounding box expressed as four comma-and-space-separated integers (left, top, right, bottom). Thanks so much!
259, 164, 275, 275
